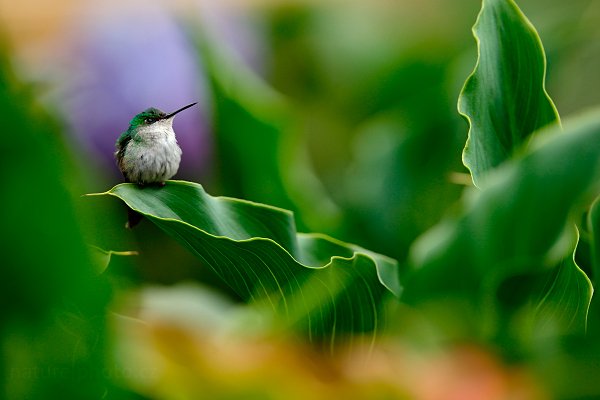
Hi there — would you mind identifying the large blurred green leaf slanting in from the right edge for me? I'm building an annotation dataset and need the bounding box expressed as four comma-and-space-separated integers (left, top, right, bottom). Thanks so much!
403, 112, 600, 340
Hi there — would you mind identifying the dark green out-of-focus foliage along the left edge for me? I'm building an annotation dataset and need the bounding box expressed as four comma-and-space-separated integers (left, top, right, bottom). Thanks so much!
0, 41, 110, 399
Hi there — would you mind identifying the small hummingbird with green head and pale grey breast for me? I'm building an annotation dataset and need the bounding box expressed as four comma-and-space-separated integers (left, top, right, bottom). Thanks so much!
115, 103, 196, 186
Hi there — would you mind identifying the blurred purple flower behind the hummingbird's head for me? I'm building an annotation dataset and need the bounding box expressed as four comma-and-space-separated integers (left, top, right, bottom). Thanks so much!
64, 2, 211, 179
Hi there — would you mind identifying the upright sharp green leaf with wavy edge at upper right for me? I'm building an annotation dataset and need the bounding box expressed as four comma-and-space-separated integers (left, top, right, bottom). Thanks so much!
458, 0, 559, 186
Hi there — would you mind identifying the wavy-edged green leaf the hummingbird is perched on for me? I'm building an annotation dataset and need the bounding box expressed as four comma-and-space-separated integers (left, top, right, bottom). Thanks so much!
88, 181, 400, 341
